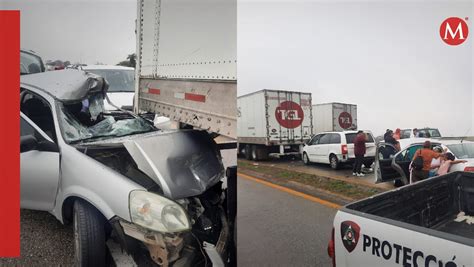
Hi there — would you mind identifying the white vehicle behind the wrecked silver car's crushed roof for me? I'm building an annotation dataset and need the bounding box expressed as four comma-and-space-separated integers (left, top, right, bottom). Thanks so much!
69, 64, 135, 110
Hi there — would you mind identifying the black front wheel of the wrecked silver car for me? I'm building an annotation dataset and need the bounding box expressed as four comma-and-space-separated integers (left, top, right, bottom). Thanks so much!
73, 200, 106, 266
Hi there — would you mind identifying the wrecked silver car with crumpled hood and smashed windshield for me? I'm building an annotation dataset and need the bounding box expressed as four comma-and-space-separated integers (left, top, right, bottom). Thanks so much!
20, 70, 233, 266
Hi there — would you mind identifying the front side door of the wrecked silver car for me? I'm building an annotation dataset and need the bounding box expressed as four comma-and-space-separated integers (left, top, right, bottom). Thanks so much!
20, 112, 59, 211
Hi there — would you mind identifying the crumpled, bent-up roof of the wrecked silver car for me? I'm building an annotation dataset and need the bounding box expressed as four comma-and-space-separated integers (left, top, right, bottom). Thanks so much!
20, 69, 108, 102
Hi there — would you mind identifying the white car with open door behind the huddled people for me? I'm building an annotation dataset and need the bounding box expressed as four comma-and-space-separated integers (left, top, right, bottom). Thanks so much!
374, 138, 474, 186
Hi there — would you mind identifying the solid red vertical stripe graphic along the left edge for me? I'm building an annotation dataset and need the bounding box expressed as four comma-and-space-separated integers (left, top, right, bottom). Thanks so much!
0, 10, 20, 257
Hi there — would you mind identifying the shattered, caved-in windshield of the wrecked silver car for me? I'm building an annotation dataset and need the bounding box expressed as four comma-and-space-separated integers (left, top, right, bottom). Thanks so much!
58, 94, 157, 143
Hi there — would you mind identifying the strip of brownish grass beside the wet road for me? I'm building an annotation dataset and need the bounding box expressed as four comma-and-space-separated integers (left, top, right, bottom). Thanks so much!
238, 161, 382, 200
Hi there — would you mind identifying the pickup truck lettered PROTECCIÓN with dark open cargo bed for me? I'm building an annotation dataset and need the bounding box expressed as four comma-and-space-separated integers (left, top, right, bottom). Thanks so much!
328, 172, 474, 267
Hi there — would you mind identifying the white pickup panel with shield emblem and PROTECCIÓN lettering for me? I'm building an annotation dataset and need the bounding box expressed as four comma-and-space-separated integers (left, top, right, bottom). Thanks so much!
334, 211, 474, 267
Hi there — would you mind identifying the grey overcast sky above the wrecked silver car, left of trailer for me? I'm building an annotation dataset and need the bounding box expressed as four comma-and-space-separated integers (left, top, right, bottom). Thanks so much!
0, 0, 137, 65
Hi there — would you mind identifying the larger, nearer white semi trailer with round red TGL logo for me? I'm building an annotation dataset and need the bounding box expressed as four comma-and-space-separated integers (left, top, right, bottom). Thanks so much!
237, 89, 313, 160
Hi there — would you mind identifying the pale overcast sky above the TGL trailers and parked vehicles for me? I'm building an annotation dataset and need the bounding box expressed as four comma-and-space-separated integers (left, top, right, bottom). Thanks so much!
238, 0, 474, 136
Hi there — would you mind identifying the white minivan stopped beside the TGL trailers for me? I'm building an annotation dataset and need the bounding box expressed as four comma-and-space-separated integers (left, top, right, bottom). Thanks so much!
302, 131, 375, 169
